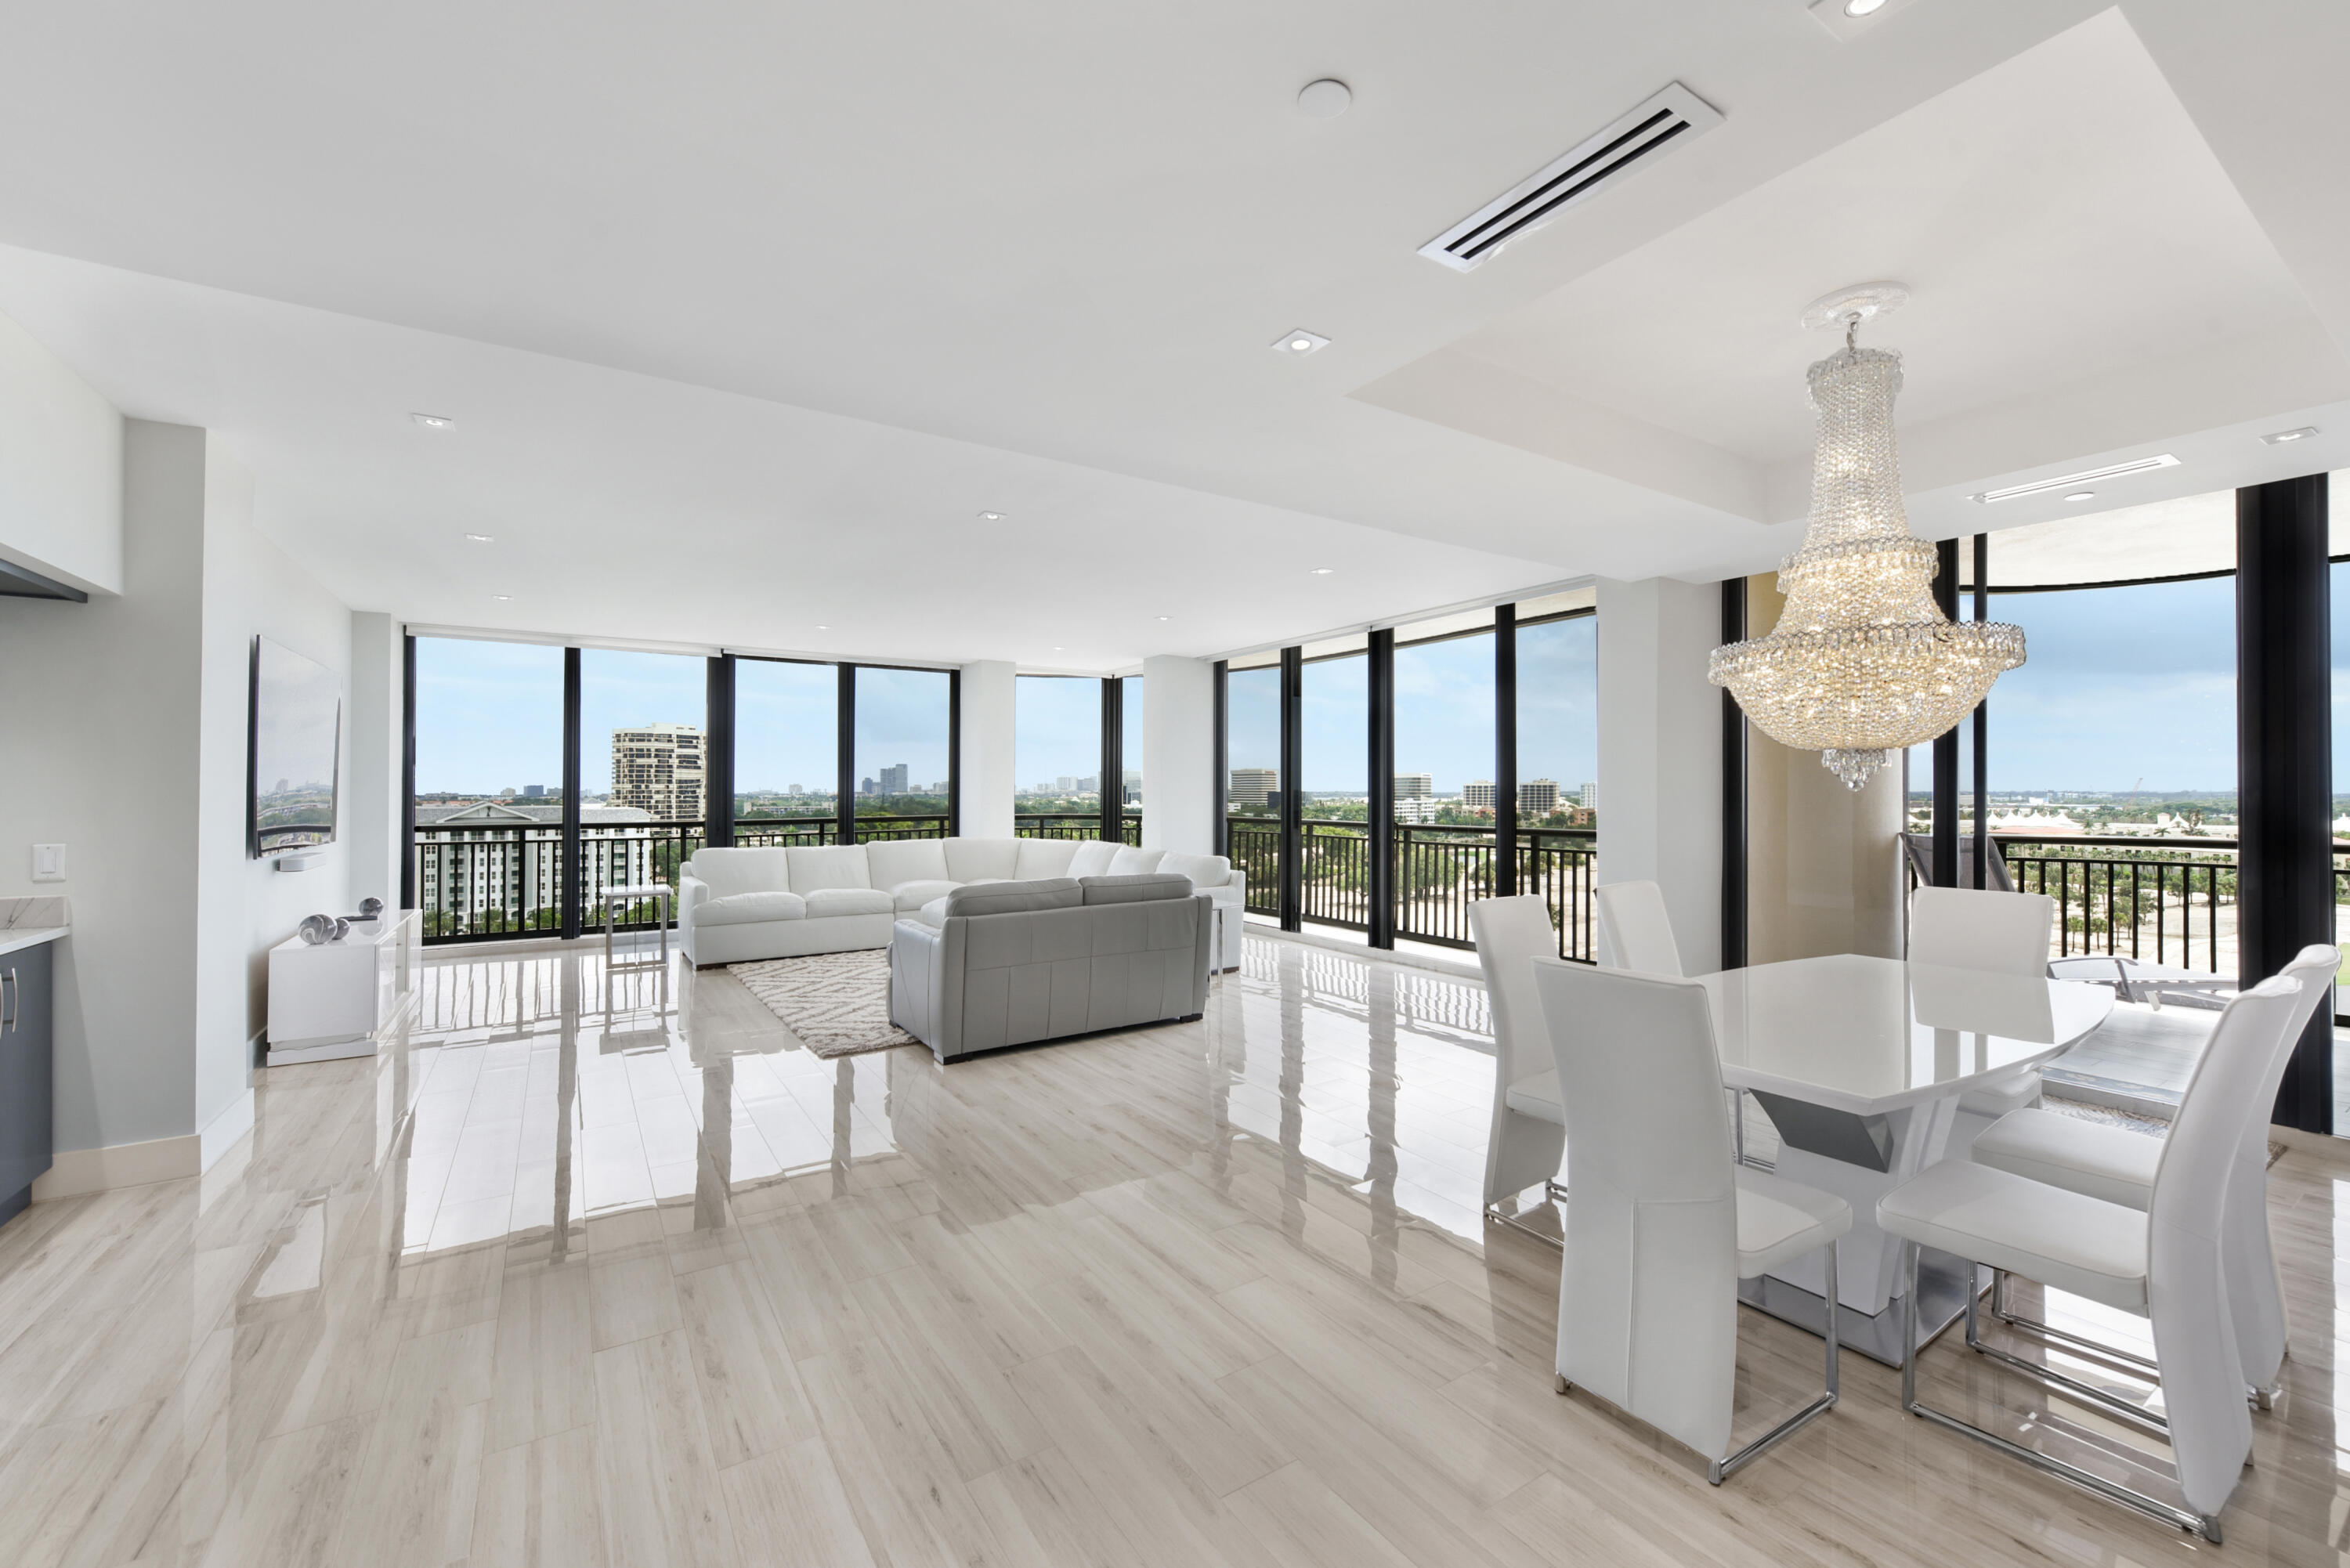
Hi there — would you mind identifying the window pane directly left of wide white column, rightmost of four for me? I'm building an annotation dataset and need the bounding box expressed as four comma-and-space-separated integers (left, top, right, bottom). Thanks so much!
1497, 604, 1600, 957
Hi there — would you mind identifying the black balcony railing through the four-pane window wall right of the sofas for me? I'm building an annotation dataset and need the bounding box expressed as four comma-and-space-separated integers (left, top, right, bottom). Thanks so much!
1227, 816, 1598, 962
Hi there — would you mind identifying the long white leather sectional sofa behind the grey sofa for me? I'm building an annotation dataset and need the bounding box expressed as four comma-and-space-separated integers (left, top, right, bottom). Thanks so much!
677, 840, 1248, 969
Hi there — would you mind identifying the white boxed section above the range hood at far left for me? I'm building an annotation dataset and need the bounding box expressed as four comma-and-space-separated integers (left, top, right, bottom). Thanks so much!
0, 315, 122, 592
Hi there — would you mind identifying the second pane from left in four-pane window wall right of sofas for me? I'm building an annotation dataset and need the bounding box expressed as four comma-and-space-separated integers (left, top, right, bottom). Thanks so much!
1297, 637, 1370, 931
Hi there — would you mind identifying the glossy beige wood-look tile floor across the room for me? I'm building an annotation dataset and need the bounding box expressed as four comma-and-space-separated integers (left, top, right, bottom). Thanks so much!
0, 941, 2350, 1568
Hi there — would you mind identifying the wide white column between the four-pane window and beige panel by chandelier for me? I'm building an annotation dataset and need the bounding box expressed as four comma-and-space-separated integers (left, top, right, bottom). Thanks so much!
1598, 578, 1723, 974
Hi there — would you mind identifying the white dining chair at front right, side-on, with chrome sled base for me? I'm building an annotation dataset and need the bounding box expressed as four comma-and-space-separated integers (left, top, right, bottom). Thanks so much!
1878, 976, 2303, 1545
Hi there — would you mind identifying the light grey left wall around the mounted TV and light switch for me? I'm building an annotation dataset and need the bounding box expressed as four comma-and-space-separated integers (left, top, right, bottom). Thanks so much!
0, 421, 350, 1175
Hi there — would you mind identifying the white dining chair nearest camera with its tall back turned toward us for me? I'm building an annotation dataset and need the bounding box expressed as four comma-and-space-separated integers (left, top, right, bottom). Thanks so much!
1535, 957, 1852, 1486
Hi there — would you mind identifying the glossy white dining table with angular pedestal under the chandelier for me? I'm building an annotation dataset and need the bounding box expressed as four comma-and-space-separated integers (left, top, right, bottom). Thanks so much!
1701, 955, 2115, 1366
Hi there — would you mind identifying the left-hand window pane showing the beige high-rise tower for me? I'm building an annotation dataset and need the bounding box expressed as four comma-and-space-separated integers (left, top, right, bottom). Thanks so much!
580, 649, 710, 924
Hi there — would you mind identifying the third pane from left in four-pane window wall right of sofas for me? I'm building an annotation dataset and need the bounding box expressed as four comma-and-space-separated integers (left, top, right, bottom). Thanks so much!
1394, 611, 1495, 943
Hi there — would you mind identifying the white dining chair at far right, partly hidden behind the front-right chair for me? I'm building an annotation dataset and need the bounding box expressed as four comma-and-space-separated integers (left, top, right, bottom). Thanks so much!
1974, 943, 2343, 1411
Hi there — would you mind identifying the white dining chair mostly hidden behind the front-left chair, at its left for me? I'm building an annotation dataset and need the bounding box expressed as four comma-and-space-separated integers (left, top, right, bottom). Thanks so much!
1469, 896, 1567, 1246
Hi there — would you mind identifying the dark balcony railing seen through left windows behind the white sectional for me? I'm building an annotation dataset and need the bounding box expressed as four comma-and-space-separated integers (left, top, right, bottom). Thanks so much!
416, 814, 947, 943
